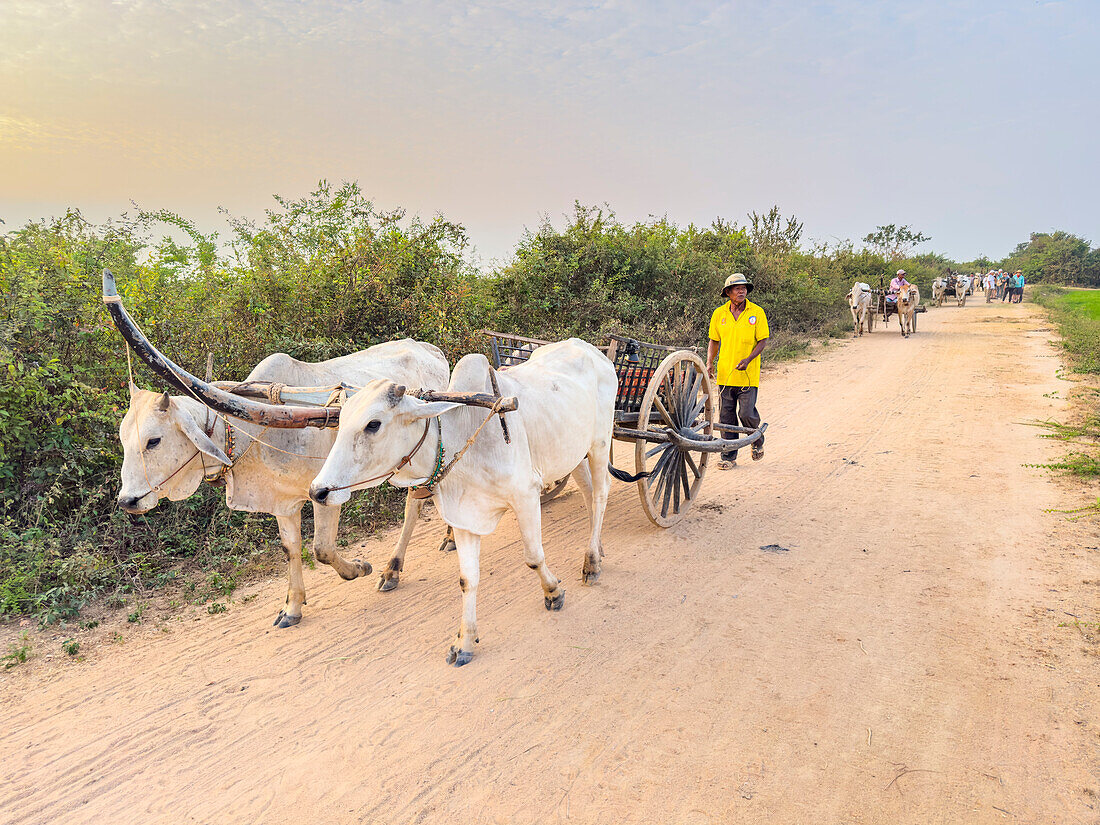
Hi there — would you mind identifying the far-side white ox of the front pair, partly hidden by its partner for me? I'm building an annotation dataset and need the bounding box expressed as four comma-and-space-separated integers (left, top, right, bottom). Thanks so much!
118, 339, 449, 627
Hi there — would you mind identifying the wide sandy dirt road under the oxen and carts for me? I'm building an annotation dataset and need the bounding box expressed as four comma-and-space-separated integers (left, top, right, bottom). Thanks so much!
0, 301, 1100, 825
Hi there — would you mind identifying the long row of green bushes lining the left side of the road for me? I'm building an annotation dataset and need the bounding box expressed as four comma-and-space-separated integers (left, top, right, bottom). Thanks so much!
0, 183, 1096, 620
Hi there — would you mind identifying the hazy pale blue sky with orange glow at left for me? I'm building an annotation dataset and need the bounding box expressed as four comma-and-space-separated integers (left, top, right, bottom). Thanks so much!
0, 0, 1100, 261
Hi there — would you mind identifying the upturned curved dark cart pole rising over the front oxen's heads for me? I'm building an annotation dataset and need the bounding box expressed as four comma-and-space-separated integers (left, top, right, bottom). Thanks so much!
103, 270, 340, 429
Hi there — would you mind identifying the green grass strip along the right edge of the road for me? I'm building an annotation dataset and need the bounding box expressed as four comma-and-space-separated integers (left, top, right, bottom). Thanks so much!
1031, 285, 1100, 513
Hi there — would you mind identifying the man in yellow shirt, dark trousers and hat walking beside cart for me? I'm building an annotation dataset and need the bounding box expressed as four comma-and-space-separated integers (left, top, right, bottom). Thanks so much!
706, 273, 769, 470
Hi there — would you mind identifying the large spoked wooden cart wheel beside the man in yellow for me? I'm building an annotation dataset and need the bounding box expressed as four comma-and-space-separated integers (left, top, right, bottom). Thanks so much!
634, 350, 718, 527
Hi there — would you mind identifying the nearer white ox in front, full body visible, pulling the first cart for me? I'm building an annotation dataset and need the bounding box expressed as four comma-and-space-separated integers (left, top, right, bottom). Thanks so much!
310, 338, 631, 667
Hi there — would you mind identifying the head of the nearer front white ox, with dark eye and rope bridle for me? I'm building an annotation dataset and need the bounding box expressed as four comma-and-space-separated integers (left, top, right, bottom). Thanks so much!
309, 380, 462, 505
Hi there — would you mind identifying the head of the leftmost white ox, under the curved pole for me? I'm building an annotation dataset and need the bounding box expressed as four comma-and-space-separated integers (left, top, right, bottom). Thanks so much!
119, 384, 231, 514
